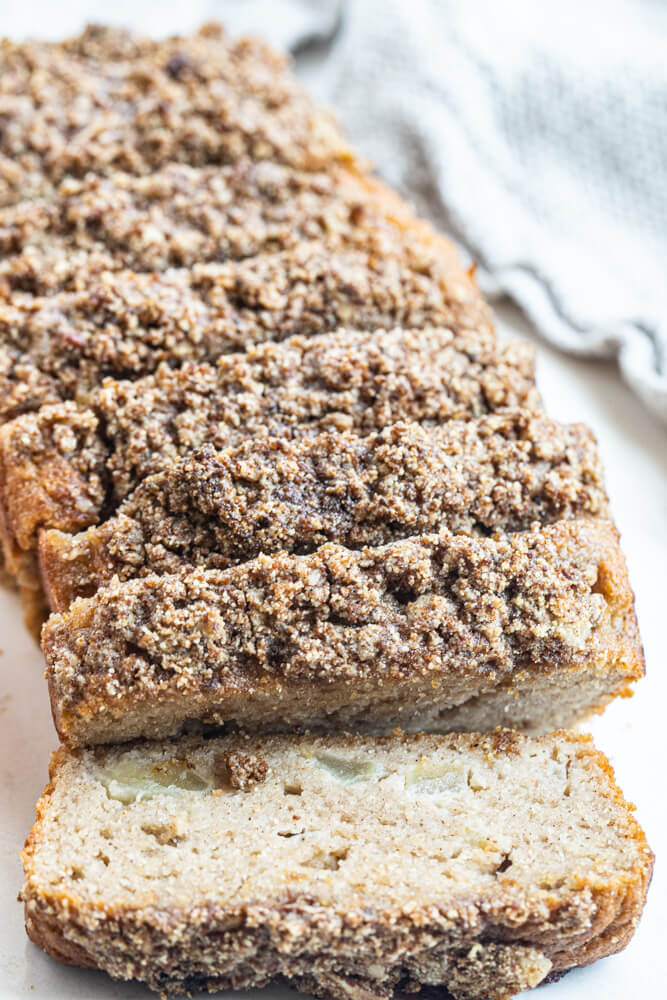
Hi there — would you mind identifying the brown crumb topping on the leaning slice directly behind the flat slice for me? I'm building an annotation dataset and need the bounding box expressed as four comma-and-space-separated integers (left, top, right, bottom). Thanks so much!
43, 521, 631, 711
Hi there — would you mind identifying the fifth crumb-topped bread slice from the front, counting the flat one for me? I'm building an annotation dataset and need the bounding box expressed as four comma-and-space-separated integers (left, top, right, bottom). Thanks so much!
0, 242, 491, 420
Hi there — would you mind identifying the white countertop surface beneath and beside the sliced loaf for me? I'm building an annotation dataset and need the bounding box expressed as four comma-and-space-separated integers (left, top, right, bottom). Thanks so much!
0, 307, 667, 1000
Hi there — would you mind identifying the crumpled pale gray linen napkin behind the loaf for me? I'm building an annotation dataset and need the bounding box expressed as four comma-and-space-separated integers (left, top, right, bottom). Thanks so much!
7, 0, 667, 420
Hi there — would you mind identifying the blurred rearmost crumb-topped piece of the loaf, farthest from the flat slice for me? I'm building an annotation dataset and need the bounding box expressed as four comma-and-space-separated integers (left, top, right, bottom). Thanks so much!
0, 25, 353, 205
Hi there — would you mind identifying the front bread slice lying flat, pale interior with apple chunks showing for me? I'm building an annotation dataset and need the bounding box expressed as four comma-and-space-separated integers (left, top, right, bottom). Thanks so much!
22, 731, 653, 1000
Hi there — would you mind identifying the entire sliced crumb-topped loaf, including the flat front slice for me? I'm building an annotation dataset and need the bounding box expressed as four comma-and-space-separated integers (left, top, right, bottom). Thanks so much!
0, 26, 652, 1000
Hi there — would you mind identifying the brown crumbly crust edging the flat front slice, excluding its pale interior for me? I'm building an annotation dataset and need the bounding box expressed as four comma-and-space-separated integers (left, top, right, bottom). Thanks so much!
22, 732, 653, 1000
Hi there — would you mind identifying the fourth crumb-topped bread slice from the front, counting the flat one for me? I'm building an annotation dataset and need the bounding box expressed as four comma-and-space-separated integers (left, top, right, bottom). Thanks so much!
0, 329, 539, 572
